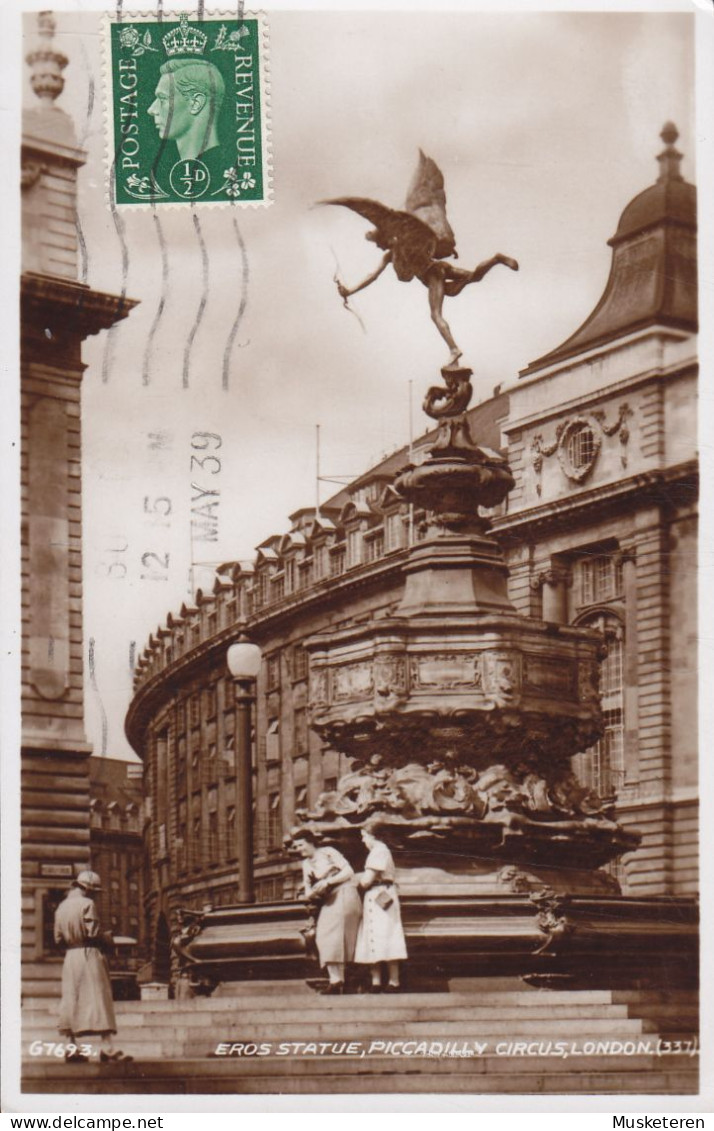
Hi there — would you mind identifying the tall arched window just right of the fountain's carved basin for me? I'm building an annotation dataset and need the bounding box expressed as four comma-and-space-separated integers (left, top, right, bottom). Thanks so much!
573, 613, 625, 797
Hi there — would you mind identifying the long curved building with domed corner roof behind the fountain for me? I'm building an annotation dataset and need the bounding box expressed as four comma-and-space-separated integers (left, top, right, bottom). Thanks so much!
127, 126, 697, 960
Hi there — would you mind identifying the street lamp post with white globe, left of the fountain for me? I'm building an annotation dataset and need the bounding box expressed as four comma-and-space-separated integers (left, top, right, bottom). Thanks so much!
226, 637, 260, 904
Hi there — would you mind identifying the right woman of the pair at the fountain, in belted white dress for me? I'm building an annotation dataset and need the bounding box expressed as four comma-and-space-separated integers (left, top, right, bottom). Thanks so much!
354, 827, 406, 993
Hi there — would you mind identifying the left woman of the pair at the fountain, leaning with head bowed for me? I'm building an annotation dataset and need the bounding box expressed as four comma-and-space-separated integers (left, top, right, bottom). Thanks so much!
293, 832, 362, 994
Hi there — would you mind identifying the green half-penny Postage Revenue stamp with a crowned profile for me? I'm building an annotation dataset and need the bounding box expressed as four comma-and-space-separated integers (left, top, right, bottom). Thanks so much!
107, 14, 270, 205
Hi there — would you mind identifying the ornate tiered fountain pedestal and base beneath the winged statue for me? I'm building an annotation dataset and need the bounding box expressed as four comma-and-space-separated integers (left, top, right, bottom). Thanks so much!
174, 370, 696, 985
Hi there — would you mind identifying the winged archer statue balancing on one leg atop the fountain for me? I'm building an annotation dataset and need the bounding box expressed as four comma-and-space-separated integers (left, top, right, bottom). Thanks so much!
322, 149, 518, 365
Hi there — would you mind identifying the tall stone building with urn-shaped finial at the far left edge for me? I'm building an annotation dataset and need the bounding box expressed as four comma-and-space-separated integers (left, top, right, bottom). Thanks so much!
20, 11, 135, 995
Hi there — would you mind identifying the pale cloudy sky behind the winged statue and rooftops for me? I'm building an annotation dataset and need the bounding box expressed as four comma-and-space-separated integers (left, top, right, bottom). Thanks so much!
20, 10, 697, 757
